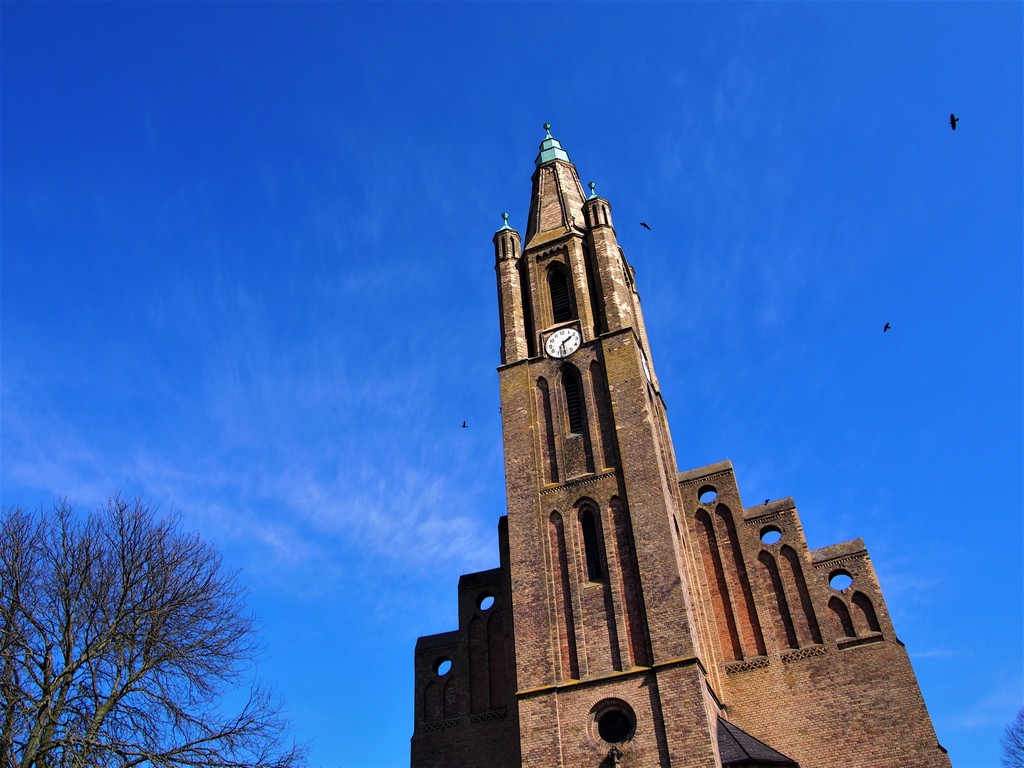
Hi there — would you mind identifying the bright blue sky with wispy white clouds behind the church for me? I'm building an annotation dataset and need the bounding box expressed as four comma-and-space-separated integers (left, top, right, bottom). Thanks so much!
0, 2, 1024, 768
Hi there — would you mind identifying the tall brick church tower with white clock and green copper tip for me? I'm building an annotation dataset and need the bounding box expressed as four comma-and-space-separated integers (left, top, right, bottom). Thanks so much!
495, 126, 717, 766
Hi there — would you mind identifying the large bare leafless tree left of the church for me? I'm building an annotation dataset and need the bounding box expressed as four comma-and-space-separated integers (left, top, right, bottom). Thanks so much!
0, 498, 304, 768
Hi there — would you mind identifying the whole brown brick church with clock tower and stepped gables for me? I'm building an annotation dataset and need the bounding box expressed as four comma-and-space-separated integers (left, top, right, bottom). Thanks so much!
412, 126, 949, 768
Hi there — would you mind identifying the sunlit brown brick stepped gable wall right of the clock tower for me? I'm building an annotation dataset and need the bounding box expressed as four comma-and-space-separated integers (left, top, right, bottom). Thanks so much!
680, 463, 949, 768
